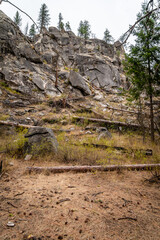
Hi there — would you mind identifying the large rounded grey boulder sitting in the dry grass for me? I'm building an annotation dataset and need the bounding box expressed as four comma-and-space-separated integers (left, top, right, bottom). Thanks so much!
24, 127, 58, 155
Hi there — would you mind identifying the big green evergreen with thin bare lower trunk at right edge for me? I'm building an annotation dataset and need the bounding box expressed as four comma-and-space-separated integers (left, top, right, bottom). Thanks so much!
125, 3, 160, 141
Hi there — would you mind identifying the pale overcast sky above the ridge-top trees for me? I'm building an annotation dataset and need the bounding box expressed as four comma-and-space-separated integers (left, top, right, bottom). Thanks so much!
0, 0, 144, 40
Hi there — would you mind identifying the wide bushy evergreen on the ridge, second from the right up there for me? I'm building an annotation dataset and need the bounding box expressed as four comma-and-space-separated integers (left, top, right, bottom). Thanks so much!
78, 20, 91, 39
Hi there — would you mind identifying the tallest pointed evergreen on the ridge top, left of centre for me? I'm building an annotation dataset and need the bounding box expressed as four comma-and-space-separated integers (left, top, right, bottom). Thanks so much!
38, 3, 50, 32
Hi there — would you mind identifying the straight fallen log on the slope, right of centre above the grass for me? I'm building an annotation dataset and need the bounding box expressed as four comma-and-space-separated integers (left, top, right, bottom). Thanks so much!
73, 116, 144, 129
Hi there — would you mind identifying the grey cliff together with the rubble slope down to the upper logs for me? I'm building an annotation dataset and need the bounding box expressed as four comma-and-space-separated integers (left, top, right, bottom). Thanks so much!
0, 11, 159, 131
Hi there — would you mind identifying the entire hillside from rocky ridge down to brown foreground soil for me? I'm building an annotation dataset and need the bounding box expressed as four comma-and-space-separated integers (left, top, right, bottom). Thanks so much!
0, 11, 160, 240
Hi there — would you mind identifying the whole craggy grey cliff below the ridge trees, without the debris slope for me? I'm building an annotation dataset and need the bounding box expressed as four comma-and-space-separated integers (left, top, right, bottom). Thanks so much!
0, 11, 125, 102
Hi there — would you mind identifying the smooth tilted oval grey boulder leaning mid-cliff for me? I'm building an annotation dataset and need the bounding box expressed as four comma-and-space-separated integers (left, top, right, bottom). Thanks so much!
69, 71, 91, 95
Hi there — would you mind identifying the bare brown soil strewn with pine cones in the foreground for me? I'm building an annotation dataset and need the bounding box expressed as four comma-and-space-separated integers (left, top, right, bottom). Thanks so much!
0, 160, 160, 240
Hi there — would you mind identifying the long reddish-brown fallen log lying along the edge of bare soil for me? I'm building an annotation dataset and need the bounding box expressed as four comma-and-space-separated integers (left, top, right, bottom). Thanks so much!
26, 164, 160, 173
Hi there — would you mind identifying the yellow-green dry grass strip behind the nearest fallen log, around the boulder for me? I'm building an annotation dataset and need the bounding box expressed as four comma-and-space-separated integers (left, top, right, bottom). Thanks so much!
0, 127, 160, 165
